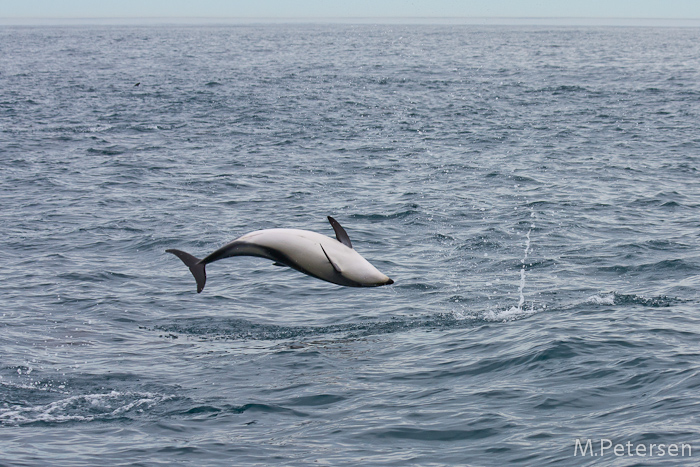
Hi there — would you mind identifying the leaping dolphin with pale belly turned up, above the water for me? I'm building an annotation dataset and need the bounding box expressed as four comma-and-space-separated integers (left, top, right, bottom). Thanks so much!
165, 216, 394, 293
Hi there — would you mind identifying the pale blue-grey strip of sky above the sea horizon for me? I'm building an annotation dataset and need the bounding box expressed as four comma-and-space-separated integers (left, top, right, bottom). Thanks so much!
0, 0, 700, 20
